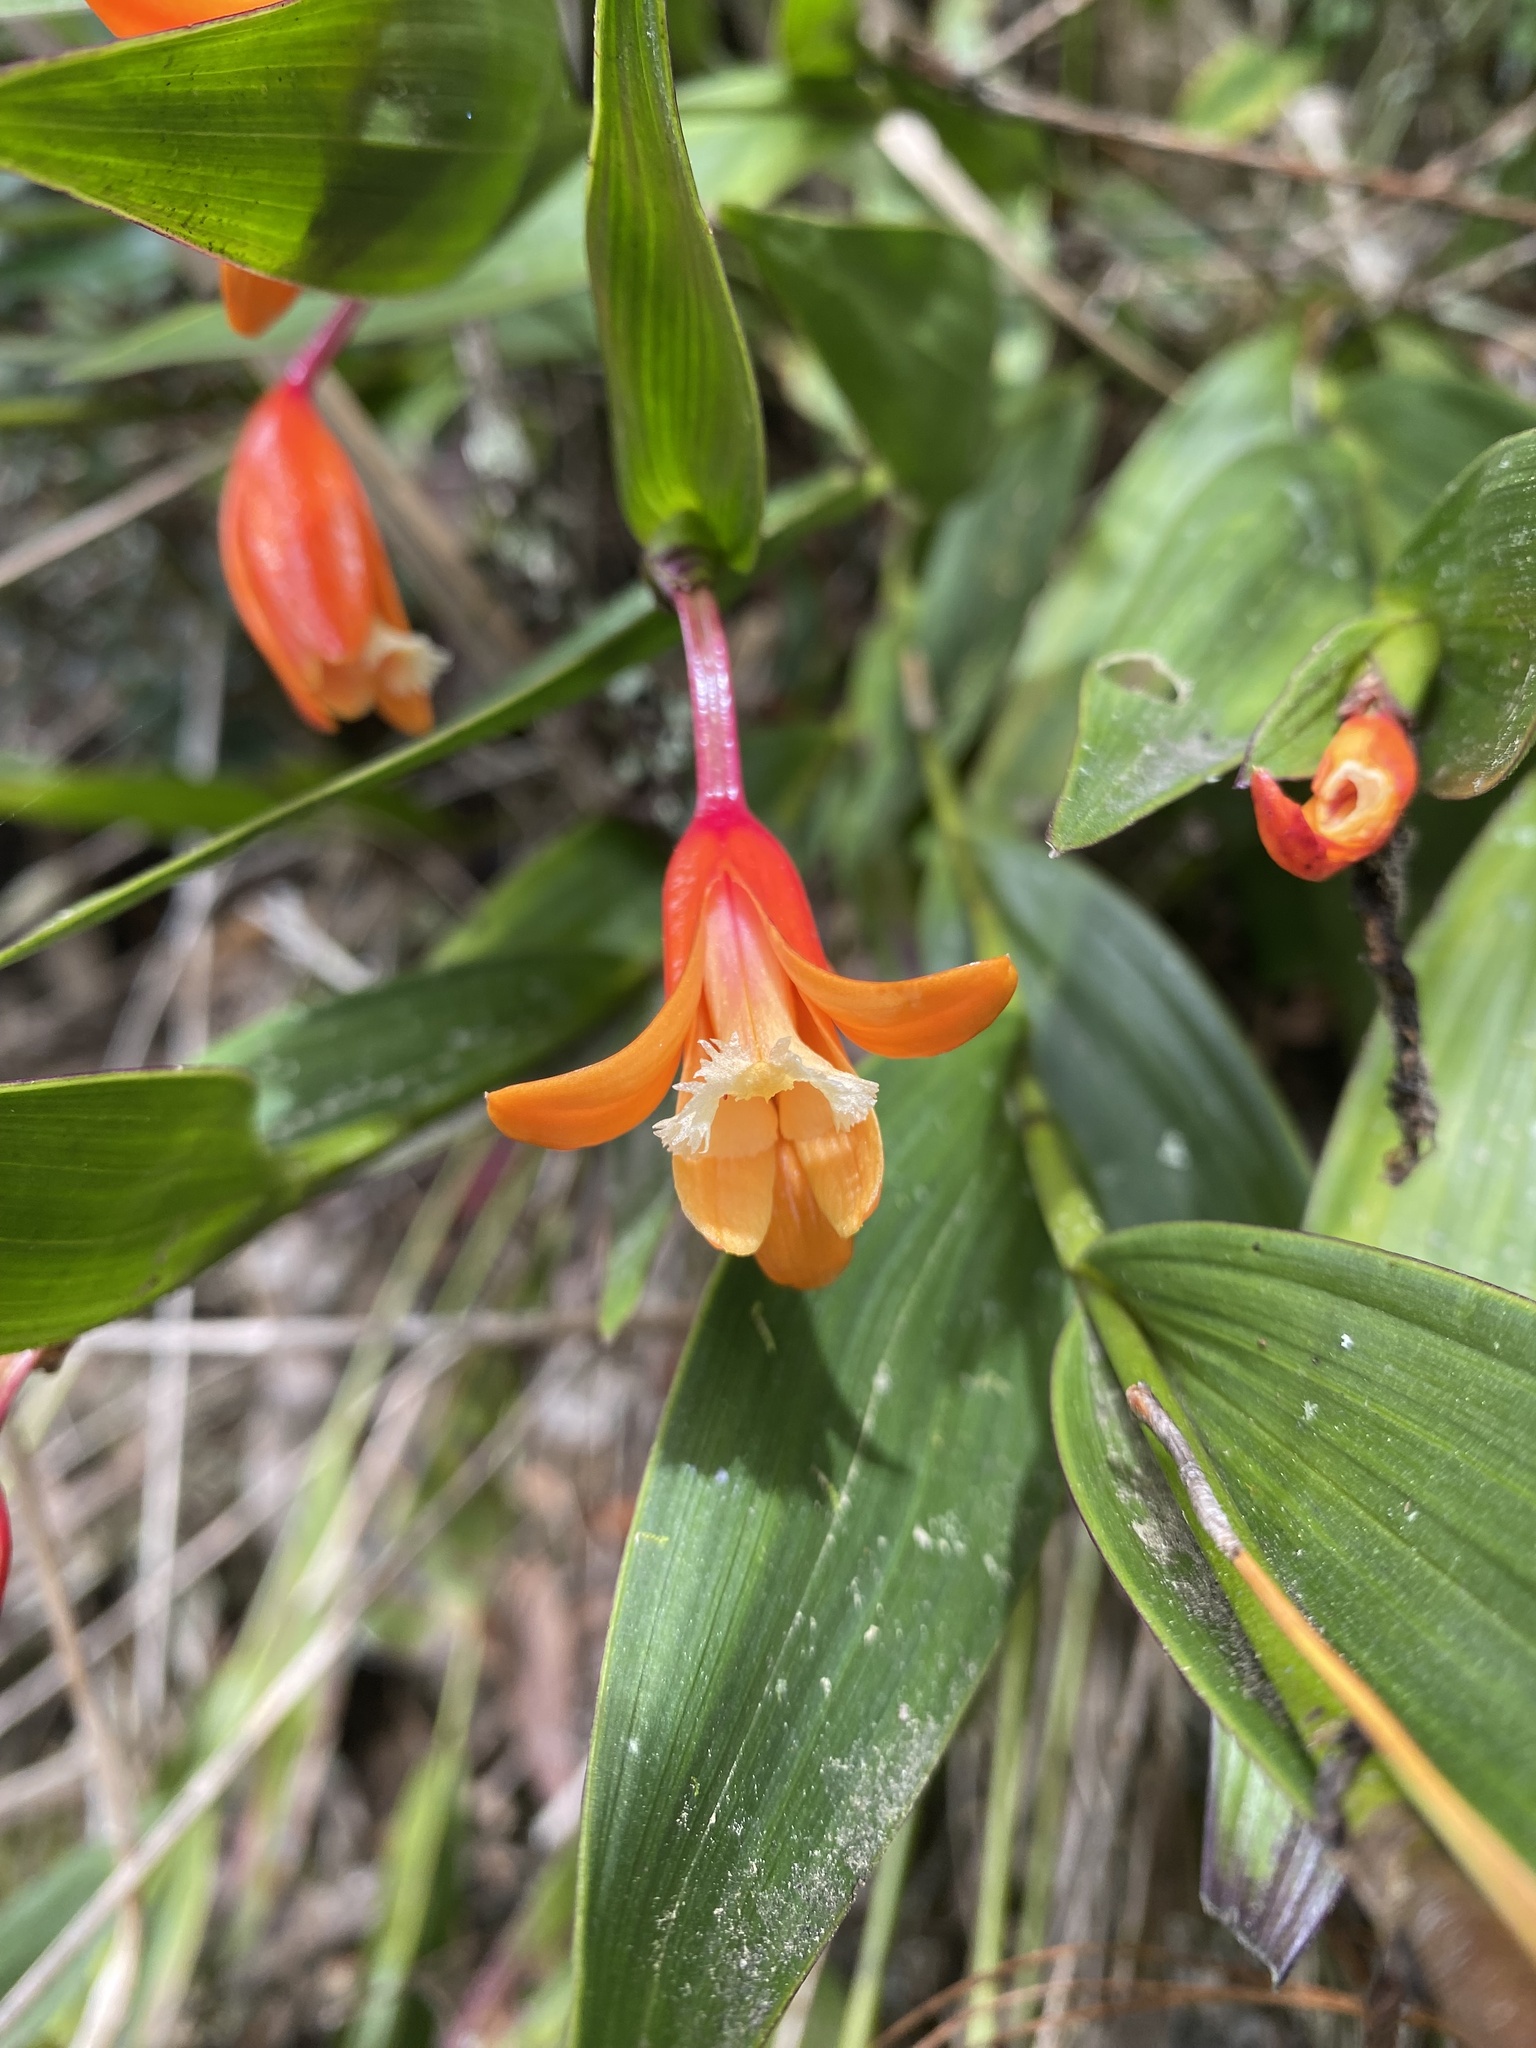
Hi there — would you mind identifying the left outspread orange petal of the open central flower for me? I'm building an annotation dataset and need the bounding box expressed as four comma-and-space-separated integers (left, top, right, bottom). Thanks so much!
485, 942, 705, 1151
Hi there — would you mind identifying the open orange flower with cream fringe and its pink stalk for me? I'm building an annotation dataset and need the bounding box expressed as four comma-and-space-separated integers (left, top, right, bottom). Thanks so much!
485, 590, 1018, 1288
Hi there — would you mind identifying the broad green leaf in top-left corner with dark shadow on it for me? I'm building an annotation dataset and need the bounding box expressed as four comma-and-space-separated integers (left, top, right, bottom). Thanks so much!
0, 0, 565, 293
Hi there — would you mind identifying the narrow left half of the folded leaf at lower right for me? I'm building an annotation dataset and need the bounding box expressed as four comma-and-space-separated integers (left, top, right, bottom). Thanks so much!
1051, 1313, 1313, 1812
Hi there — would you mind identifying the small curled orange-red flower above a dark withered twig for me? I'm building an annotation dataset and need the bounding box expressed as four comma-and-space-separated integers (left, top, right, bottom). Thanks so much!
1251, 711, 1419, 883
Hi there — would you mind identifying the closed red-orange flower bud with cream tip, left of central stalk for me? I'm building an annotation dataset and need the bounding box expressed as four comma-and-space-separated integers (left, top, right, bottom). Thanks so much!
219, 383, 449, 733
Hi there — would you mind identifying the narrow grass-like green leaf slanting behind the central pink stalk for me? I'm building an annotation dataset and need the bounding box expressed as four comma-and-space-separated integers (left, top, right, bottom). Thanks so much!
0, 469, 877, 967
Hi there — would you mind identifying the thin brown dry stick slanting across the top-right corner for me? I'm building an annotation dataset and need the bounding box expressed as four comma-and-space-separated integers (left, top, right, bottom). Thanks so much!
974, 74, 1536, 227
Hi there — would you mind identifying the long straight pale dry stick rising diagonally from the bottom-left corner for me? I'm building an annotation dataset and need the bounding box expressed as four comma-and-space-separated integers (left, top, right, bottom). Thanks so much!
0, 1374, 557, 2040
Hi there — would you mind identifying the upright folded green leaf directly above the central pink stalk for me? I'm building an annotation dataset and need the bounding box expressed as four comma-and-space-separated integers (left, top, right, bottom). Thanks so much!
586, 0, 766, 569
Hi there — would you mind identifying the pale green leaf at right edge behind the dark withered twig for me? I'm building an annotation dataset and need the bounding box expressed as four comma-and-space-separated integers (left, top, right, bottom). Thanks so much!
1307, 778, 1536, 1294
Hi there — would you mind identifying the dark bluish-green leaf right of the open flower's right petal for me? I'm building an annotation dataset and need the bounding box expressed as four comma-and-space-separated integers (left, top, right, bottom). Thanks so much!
977, 836, 1307, 1229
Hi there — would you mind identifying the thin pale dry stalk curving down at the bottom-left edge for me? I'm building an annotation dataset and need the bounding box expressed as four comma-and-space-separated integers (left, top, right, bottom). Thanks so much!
6, 1436, 143, 2048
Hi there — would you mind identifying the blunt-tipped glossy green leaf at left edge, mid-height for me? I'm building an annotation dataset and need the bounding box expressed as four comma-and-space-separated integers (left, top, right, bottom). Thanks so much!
0, 1073, 287, 1352
